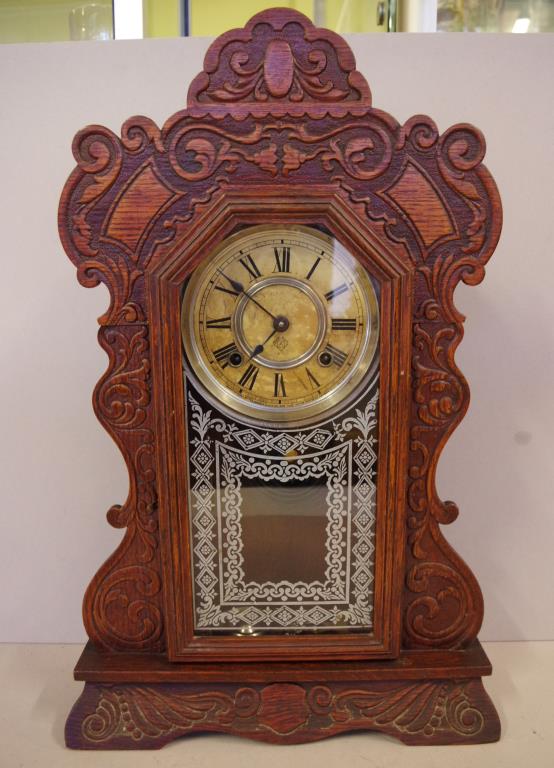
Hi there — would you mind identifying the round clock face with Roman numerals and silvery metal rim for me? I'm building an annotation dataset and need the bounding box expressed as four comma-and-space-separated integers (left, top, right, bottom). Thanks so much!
182, 226, 379, 422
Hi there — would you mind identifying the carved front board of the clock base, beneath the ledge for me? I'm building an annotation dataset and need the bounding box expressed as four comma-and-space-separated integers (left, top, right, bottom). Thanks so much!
66, 680, 499, 749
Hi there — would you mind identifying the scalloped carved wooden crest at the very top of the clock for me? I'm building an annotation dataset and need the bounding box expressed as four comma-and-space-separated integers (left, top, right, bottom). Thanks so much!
187, 8, 371, 116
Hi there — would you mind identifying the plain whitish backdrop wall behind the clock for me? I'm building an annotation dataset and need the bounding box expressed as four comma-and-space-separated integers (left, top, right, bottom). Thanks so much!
0, 34, 554, 642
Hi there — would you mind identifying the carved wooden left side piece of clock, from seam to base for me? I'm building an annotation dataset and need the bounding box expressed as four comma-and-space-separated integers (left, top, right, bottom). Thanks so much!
84, 326, 163, 650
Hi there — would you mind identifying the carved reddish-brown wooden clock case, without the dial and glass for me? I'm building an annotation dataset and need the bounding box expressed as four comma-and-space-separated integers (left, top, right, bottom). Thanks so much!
59, 9, 501, 749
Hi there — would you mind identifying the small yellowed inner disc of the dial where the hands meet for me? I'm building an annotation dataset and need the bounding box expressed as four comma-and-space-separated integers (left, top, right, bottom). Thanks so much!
233, 277, 327, 370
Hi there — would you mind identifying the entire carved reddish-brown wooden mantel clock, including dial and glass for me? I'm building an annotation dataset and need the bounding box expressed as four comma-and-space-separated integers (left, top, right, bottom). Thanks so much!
59, 9, 501, 749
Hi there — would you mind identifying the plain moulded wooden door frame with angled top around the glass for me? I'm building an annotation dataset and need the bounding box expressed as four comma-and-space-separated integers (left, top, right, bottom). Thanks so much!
148, 185, 412, 662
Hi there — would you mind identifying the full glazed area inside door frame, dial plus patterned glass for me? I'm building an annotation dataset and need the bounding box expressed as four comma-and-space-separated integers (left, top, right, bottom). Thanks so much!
182, 225, 379, 635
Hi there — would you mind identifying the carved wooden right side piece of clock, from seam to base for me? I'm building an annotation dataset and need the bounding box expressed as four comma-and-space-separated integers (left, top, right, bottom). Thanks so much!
404, 304, 483, 647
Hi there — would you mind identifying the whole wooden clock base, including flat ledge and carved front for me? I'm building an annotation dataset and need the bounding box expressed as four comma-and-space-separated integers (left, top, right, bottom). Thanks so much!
65, 641, 500, 749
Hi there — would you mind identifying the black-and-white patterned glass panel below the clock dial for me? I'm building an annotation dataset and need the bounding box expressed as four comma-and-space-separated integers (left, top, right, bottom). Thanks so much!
186, 377, 378, 634
